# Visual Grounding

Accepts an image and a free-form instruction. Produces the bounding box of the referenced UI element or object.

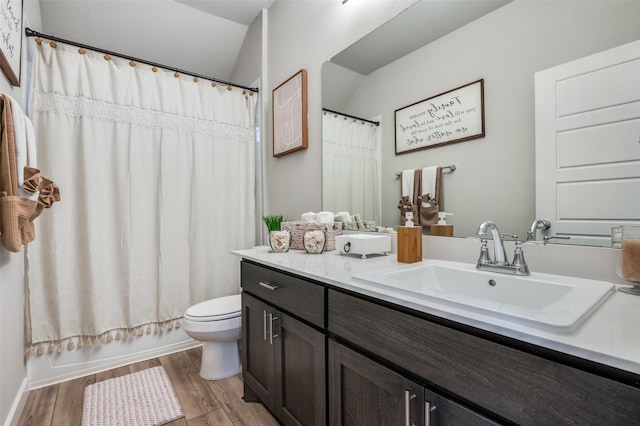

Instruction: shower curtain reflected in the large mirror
[322,113,382,225]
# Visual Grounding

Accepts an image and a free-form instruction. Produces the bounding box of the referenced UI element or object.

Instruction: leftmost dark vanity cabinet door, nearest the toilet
[242,293,275,409]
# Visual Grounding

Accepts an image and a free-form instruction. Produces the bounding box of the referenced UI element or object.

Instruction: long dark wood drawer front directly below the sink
[328,290,640,425]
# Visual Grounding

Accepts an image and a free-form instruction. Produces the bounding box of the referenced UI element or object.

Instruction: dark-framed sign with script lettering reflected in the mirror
[395,79,485,155]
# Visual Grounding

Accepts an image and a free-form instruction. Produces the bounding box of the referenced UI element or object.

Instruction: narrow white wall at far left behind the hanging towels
[0,0,40,424]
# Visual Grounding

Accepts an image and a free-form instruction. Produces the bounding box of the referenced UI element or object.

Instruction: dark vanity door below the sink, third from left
[329,340,425,426]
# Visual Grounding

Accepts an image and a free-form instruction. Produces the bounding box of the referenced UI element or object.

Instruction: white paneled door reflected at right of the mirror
[535,41,640,245]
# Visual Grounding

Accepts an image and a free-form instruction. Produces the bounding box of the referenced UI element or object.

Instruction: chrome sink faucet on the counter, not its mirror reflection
[476,221,531,275]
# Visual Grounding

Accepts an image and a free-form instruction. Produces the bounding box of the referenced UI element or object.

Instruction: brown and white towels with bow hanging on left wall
[0,94,60,252]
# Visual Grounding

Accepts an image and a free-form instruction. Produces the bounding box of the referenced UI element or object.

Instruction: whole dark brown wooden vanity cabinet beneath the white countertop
[241,260,640,426]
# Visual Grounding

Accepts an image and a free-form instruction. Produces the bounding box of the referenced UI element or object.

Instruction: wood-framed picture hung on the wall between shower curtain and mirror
[272,69,307,157]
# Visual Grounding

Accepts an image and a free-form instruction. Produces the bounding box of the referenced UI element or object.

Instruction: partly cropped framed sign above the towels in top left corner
[0,0,22,86]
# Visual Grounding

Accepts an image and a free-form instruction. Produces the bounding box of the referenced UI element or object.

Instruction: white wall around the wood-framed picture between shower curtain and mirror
[262,0,414,219]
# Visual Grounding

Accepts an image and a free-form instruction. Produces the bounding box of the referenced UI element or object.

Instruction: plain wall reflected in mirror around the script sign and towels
[344,1,640,238]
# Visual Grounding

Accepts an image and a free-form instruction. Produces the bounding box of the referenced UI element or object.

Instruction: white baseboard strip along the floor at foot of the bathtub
[29,339,202,390]
